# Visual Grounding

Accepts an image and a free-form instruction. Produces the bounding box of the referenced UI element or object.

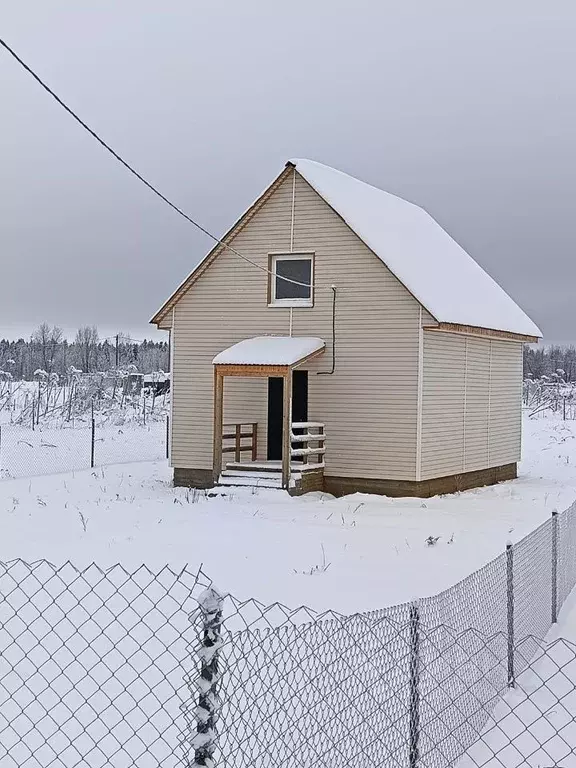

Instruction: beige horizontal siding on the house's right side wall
[421,331,522,479]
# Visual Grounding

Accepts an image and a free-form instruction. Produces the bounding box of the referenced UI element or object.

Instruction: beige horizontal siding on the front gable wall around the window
[172,175,424,480]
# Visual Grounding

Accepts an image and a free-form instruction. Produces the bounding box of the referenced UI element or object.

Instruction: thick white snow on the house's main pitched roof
[290,160,542,336]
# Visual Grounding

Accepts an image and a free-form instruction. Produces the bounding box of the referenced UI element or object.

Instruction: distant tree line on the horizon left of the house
[0,323,170,379]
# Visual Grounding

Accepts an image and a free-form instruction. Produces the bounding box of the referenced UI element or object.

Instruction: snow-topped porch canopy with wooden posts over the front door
[213,336,326,488]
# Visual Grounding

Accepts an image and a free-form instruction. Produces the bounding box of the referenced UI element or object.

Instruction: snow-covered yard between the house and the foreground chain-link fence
[0,408,576,613]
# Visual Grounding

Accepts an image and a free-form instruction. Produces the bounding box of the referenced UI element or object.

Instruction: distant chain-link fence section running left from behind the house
[0,417,169,478]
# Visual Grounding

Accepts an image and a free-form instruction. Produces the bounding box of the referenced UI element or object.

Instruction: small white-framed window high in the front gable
[270,253,314,307]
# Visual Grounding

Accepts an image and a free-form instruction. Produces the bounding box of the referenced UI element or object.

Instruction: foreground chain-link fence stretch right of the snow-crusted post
[211,506,576,768]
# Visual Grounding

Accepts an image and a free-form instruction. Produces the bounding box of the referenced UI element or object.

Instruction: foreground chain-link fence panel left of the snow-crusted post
[0,561,198,768]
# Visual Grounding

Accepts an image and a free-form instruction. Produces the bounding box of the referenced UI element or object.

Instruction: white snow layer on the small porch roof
[213,336,326,365]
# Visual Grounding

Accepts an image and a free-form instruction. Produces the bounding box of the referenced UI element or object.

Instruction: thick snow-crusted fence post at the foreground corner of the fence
[192,587,224,768]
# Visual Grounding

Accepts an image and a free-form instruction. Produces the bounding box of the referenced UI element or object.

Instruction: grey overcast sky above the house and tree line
[0,0,576,342]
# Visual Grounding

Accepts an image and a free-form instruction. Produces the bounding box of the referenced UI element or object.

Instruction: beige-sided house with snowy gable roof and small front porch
[151,160,541,496]
